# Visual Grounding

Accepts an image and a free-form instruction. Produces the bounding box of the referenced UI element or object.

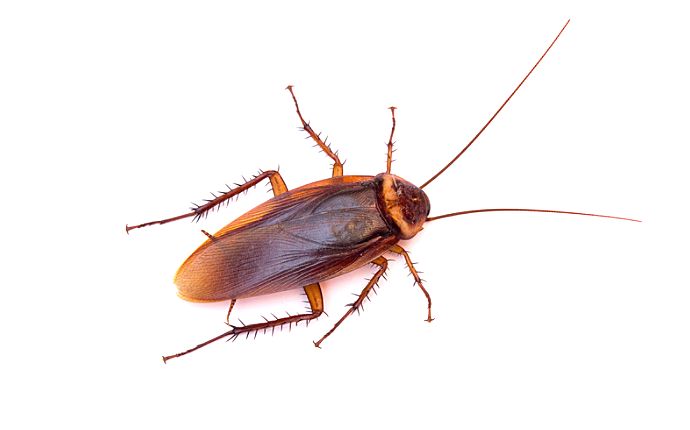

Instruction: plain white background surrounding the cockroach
[0,1,690,429]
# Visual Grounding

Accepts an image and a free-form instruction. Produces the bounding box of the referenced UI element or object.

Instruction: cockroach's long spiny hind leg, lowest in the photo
[163,284,323,362]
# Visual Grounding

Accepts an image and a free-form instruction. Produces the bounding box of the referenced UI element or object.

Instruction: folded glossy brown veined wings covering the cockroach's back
[175,177,397,301]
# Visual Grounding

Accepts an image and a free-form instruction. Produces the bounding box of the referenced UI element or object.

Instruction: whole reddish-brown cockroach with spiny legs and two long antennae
[126,20,639,362]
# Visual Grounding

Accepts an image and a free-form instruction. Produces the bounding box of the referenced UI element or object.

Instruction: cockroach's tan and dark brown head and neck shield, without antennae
[375,173,431,239]
